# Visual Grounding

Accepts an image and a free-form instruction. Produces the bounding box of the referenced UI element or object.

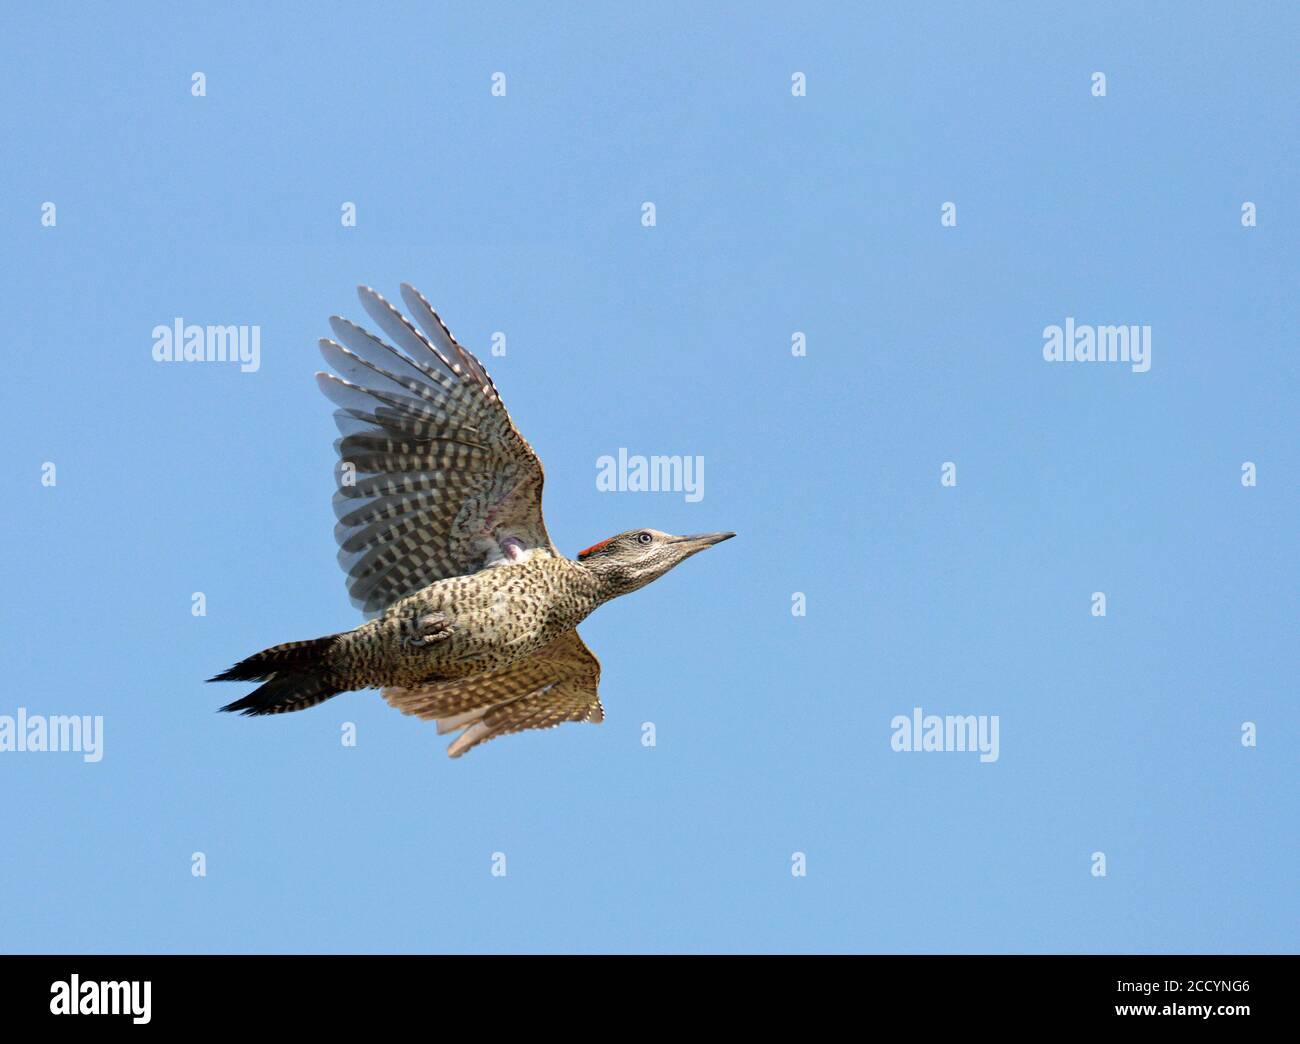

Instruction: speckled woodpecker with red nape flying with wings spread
[209,283,736,758]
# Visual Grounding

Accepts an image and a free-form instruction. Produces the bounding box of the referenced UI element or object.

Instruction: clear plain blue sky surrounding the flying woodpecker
[0,3,1300,952]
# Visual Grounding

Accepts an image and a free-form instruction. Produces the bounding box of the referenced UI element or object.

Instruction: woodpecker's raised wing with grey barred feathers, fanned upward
[316,283,558,615]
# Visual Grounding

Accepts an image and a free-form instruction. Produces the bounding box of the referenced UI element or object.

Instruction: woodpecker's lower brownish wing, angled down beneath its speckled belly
[384,631,605,758]
